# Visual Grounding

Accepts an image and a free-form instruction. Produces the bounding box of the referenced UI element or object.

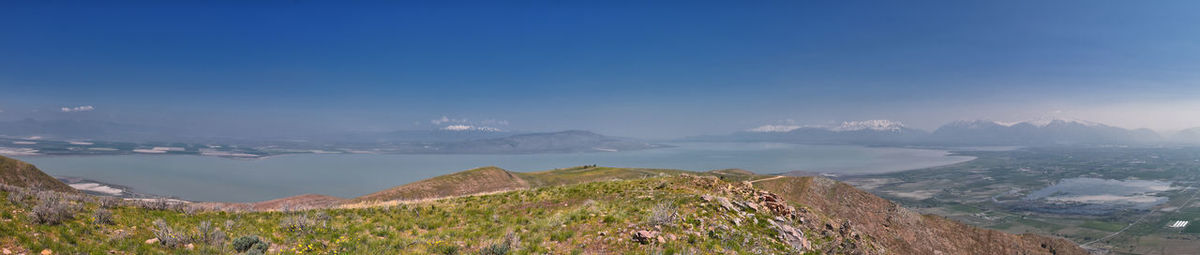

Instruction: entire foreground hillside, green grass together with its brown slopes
[0,157,1085,254]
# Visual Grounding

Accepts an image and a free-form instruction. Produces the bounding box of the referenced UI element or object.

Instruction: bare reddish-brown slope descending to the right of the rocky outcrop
[754,177,1087,254]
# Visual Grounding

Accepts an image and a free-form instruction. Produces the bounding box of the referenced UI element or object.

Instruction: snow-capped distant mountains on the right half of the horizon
[683,119,1200,146]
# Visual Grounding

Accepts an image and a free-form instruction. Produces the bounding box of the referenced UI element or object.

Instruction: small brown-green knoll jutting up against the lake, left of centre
[349,166,529,203]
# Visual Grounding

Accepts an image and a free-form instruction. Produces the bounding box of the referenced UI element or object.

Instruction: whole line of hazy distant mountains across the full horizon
[0,119,1200,154]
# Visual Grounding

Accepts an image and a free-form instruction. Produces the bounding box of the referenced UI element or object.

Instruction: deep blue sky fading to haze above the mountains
[0,0,1200,137]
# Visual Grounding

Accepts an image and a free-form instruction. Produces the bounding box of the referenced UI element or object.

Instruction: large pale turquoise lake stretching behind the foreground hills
[19,143,973,202]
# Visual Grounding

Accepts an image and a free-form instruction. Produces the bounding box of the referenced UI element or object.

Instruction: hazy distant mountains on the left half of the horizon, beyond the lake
[0,119,667,153]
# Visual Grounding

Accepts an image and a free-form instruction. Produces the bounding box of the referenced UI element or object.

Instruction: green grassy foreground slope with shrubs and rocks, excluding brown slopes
[0,173,824,254]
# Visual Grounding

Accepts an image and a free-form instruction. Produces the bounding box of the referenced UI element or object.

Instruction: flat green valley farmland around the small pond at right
[840,147,1200,254]
